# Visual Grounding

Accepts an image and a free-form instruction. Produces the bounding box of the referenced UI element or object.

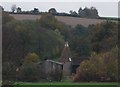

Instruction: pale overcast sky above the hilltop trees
[0,0,118,17]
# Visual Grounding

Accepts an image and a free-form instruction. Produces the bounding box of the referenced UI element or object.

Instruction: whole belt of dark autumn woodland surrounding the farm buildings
[2,9,118,82]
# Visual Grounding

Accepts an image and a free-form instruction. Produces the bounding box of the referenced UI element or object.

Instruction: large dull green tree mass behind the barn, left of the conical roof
[14,19,64,60]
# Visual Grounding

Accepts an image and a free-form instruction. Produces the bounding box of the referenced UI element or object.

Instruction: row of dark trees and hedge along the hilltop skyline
[3,5,99,18]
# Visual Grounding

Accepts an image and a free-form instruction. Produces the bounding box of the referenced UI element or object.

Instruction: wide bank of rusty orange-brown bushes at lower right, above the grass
[74,47,118,82]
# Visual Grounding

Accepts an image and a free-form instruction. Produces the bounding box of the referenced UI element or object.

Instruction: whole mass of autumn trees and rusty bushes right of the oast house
[74,21,119,81]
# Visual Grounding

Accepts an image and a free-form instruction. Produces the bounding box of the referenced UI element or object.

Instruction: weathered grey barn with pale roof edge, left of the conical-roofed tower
[43,60,63,81]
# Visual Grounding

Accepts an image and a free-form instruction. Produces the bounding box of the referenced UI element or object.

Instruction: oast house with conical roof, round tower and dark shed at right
[60,42,83,76]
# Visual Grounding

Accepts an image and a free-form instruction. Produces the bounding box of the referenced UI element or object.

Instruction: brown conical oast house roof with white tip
[61,42,72,62]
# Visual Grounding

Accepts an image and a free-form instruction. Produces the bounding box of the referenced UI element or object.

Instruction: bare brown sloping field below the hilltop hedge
[10,14,105,27]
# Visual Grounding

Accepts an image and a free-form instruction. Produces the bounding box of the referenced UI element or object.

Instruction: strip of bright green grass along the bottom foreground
[15,82,120,87]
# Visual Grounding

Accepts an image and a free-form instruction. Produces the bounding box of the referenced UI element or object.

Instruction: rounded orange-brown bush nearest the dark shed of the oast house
[74,60,97,81]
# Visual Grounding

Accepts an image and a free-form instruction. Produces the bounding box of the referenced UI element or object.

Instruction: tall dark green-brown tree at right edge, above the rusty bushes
[91,21,118,53]
